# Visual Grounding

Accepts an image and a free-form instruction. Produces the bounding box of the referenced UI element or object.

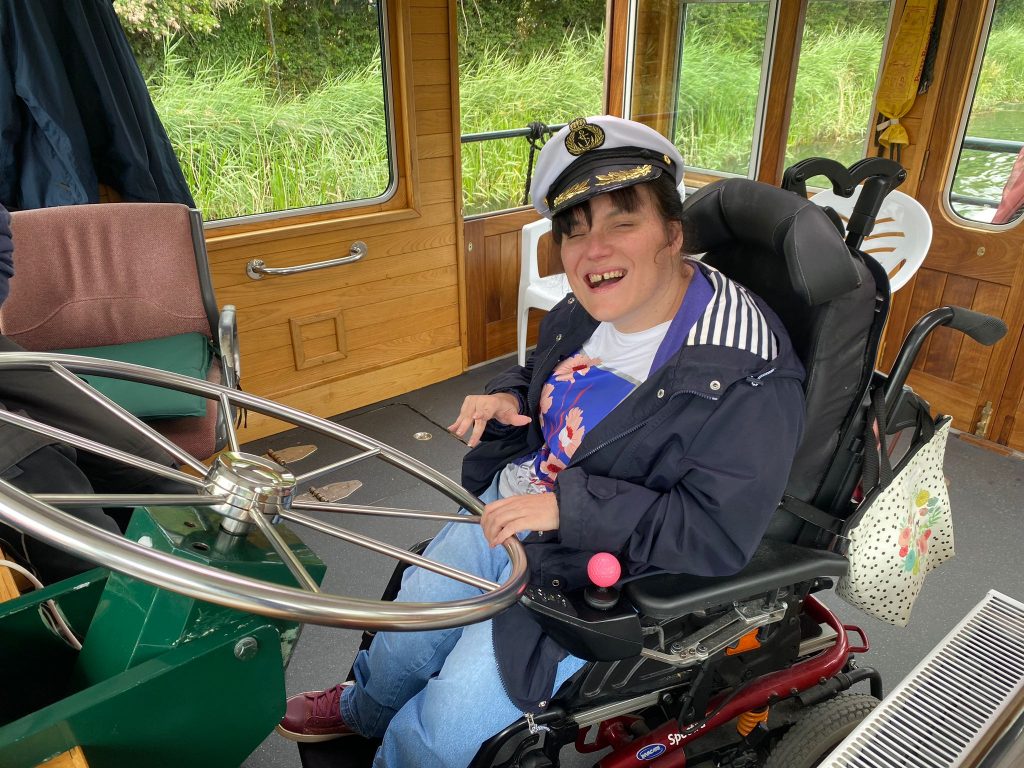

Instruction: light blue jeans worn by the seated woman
[341,481,585,768]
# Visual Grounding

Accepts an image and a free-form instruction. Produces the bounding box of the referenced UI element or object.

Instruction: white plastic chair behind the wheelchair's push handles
[811,186,932,293]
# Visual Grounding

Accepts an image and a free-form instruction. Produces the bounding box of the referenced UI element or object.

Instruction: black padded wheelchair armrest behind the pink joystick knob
[623,539,848,618]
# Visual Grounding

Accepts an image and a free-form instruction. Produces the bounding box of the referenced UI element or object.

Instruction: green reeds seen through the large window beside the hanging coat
[150,44,388,220]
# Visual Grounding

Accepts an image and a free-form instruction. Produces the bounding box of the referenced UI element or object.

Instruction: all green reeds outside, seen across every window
[150,27,1024,219]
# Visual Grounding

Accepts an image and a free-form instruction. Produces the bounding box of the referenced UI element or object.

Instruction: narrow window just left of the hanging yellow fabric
[785,0,892,166]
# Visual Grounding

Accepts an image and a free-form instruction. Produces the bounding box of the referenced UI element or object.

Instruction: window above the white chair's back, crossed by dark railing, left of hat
[457,0,606,216]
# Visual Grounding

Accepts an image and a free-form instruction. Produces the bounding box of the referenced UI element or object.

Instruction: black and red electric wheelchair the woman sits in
[300,159,1005,768]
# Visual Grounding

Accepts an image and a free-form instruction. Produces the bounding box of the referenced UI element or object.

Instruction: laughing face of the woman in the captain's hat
[561,186,687,333]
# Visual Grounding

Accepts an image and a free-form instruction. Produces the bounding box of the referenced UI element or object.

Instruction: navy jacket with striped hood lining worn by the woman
[462,264,804,713]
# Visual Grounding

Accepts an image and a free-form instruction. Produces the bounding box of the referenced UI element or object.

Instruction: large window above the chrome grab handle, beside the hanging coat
[114,0,397,223]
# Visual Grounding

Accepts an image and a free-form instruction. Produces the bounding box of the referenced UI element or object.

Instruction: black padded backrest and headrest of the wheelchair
[684,178,889,541]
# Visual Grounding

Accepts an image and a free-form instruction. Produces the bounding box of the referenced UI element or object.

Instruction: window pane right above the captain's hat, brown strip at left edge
[628,0,776,177]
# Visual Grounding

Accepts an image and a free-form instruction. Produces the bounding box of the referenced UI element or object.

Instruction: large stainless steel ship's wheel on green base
[0,352,526,630]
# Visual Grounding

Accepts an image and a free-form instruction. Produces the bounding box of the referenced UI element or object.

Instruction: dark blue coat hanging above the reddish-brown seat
[0,0,195,210]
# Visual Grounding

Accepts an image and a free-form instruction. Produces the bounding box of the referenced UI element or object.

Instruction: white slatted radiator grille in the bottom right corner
[820,591,1024,768]
